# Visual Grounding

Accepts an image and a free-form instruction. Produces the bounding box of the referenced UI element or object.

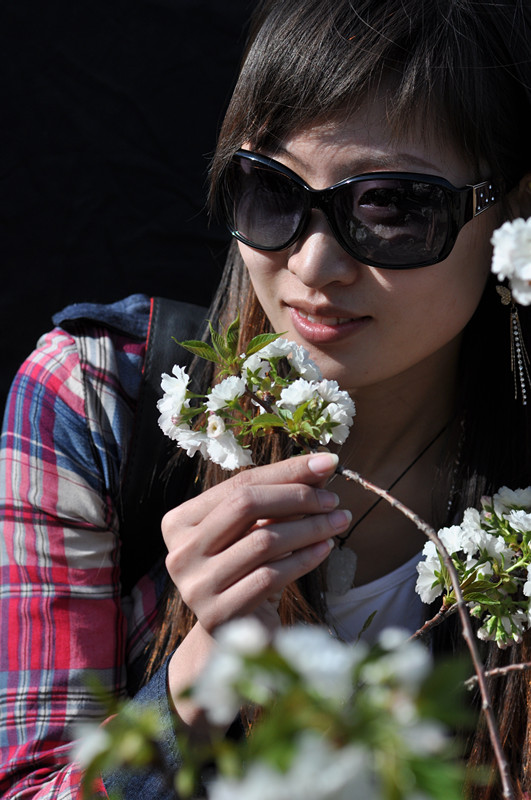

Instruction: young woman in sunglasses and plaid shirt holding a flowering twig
[1,0,531,798]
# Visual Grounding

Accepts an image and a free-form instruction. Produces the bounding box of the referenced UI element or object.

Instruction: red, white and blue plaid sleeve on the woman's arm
[0,322,147,800]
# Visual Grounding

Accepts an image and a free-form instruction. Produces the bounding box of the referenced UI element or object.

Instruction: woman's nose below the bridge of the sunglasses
[288,210,361,289]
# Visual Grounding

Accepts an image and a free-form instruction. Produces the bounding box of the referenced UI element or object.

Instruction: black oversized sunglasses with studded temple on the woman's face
[219,150,500,269]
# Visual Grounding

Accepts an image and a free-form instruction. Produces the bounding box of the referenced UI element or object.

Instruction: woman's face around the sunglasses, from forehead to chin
[239,103,499,391]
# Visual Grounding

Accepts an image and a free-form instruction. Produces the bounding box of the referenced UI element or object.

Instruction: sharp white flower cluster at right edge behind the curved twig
[416,486,531,648]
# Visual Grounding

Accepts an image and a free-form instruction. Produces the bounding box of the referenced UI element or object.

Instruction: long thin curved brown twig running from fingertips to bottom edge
[336,466,515,800]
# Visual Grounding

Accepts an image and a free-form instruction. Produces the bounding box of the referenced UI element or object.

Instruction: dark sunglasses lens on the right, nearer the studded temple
[334,178,450,267]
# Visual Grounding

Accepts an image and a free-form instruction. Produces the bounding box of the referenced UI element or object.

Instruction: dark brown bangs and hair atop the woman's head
[212,0,530,203]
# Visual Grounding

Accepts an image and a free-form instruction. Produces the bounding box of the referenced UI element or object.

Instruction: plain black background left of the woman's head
[0,0,254,409]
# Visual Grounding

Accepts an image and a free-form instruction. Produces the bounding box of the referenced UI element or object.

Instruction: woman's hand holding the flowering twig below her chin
[162,453,351,633]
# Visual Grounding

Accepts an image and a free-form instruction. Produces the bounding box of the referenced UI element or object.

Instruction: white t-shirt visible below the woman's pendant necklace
[326,553,429,644]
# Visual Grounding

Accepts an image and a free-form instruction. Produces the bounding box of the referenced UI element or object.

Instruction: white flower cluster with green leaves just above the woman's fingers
[157,321,355,470]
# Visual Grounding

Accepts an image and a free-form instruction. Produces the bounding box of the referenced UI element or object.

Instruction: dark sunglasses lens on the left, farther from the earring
[225,156,304,249]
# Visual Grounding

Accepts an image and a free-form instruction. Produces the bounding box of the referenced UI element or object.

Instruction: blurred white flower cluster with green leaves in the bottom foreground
[192,618,462,800]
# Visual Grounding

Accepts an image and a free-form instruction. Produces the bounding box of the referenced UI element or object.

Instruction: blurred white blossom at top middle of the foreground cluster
[275,625,366,701]
